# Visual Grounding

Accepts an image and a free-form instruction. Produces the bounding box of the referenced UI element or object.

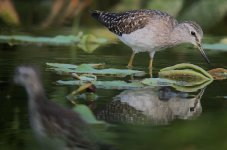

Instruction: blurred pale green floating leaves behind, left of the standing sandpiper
[0,33,108,53]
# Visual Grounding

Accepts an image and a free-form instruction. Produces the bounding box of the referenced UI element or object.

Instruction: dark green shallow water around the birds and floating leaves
[0,34,227,150]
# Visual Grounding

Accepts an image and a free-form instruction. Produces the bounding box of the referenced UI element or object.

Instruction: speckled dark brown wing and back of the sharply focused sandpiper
[91,10,169,36]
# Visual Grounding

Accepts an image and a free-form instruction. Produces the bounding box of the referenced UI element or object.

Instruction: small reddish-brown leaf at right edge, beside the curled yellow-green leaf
[208,68,227,80]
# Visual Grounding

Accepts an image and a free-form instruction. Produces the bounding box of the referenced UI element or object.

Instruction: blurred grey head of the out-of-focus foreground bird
[14,66,40,86]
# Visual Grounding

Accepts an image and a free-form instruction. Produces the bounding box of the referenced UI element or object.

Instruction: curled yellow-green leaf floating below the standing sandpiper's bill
[159,63,213,92]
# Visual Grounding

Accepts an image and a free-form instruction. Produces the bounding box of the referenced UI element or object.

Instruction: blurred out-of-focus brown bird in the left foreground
[14,66,99,150]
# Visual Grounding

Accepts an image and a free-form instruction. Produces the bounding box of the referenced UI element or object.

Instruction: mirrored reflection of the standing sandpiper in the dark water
[97,87,204,125]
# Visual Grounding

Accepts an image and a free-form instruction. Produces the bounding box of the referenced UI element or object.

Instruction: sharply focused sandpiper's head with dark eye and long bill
[180,21,210,63]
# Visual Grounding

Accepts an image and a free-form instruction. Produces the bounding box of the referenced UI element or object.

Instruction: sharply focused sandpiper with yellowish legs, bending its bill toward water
[91,9,210,76]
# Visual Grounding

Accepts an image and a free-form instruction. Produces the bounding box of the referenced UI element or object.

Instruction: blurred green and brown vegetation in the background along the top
[0,0,227,35]
